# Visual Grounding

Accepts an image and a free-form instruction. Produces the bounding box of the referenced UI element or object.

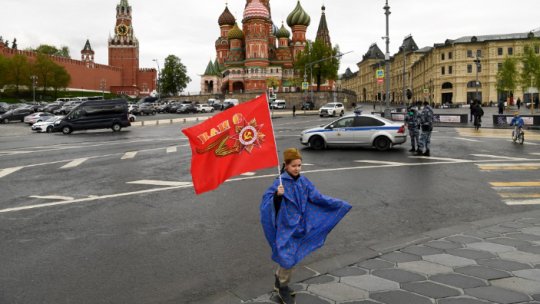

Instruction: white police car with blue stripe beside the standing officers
[300,114,407,151]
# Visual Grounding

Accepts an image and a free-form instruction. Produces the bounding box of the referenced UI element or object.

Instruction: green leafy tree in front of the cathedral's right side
[294,41,340,92]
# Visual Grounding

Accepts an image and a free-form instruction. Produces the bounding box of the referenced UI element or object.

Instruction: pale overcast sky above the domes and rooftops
[0,0,540,92]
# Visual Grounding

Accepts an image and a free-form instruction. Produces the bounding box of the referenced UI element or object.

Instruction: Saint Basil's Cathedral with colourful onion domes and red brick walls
[201,0,333,94]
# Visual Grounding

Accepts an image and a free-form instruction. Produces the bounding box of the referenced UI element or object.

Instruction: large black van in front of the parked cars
[53,99,131,134]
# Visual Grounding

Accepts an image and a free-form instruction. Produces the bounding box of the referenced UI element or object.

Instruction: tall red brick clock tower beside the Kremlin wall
[109,0,139,87]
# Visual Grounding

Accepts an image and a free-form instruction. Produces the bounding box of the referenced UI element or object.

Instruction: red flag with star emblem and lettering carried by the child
[182,95,279,194]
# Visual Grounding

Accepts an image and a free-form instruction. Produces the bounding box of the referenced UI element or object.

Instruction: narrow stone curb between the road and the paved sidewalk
[199,210,540,304]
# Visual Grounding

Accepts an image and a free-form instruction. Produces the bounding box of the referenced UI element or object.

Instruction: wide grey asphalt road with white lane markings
[0,115,540,304]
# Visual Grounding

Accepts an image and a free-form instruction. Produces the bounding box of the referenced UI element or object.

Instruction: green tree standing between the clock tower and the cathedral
[159,55,191,96]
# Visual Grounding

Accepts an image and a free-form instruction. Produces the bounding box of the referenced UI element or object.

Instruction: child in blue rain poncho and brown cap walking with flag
[261,148,351,304]
